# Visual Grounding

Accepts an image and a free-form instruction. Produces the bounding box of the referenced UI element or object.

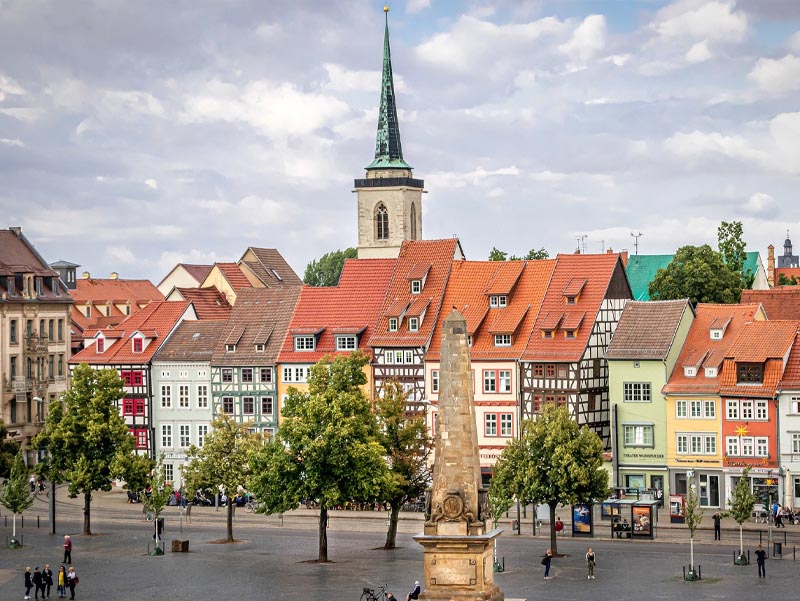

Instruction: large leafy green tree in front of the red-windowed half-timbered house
[33,364,134,534]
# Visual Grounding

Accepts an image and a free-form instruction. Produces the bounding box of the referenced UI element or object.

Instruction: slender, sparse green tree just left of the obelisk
[375,380,432,549]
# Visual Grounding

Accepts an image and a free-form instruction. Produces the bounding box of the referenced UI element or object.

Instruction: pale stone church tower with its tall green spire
[355,6,425,259]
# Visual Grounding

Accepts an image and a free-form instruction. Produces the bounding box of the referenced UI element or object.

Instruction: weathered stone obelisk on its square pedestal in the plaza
[414,309,503,601]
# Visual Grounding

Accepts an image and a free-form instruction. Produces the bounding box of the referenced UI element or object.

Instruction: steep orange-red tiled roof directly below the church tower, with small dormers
[368,238,460,348]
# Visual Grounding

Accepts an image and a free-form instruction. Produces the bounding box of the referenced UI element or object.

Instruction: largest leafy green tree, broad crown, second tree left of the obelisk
[250,352,388,562]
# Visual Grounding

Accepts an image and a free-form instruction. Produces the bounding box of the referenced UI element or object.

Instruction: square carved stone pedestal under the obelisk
[414,530,504,601]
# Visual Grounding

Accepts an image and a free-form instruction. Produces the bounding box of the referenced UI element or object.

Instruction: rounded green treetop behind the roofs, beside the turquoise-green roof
[649,244,742,305]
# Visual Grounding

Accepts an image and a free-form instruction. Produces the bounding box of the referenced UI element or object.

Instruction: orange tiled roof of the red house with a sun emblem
[720,321,800,397]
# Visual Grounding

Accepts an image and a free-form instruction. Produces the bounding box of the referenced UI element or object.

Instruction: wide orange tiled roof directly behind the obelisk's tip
[425,259,556,361]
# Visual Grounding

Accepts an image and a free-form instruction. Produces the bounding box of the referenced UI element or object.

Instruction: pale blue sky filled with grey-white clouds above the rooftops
[0,0,800,283]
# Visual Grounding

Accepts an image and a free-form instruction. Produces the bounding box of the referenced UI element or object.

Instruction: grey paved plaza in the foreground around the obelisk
[0,491,800,601]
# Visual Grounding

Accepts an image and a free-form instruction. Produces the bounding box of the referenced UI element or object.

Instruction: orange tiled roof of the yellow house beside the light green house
[663,303,764,394]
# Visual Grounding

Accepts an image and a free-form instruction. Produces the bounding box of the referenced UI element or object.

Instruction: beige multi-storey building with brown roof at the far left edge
[0,227,73,465]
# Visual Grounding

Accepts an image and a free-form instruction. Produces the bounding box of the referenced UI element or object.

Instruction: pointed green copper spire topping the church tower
[367,6,411,169]
